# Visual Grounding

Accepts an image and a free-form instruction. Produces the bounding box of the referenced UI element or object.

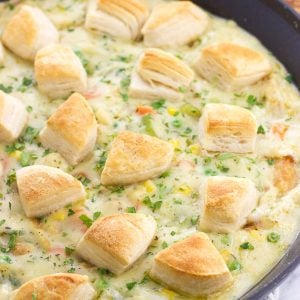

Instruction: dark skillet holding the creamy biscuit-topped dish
[0,0,300,300]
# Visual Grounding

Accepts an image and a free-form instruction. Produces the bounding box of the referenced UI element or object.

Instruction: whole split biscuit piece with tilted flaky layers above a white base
[129,48,194,100]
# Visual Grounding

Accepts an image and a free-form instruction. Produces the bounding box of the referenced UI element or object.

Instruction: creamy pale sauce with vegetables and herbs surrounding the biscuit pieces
[0,0,300,299]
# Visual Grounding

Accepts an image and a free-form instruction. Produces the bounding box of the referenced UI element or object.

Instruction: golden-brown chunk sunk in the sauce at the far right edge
[274,156,298,194]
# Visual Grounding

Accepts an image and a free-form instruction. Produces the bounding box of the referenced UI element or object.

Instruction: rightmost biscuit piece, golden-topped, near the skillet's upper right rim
[195,43,271,90]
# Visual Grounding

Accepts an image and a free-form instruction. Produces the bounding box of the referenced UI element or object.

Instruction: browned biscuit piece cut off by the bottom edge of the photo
[9,273,96,300]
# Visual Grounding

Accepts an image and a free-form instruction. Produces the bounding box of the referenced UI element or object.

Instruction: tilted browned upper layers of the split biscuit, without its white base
[137,48,194,90]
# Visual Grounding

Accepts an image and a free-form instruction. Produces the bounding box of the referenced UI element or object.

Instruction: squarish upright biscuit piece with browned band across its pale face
[199,103,257,153]
